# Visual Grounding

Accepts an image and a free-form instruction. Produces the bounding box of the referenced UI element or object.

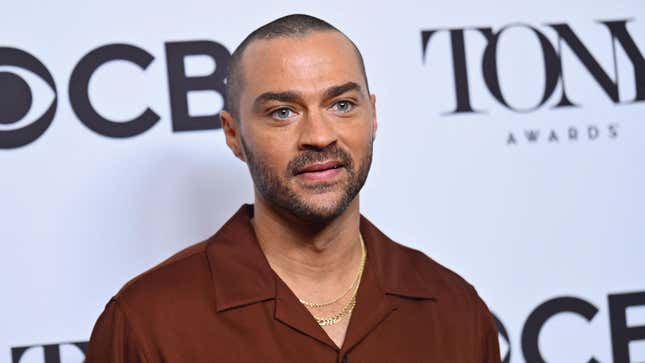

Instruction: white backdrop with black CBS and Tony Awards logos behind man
[0,0,645,363]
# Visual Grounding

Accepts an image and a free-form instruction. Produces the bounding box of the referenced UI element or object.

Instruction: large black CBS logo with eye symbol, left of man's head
[0,41,230,149]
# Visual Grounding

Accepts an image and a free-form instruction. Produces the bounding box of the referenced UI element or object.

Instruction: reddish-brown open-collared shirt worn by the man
[86,205,500,363]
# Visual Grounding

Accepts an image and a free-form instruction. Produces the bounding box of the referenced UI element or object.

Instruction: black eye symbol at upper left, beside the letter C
[0,47,58,149]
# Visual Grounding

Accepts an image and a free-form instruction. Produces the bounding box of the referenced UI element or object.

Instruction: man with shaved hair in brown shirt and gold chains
[87,15,500,363]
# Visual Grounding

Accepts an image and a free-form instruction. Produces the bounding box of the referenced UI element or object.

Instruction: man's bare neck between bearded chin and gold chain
[253,193,361,300]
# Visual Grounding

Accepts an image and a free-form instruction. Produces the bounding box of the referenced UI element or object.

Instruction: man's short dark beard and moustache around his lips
[241,138,374,224]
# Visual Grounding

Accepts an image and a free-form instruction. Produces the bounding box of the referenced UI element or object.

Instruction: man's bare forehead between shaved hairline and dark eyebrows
[240,31,366,99]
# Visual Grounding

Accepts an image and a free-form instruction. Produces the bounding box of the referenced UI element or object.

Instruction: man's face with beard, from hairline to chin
[225,31,376,222]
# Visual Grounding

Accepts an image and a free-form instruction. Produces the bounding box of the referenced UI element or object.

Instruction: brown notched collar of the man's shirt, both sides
[206,204,438,312]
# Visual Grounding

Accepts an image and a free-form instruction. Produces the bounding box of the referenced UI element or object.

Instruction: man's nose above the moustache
[298,111,337,150]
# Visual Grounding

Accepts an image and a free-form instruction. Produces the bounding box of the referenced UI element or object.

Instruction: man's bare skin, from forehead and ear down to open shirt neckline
[221,31,377,347]
